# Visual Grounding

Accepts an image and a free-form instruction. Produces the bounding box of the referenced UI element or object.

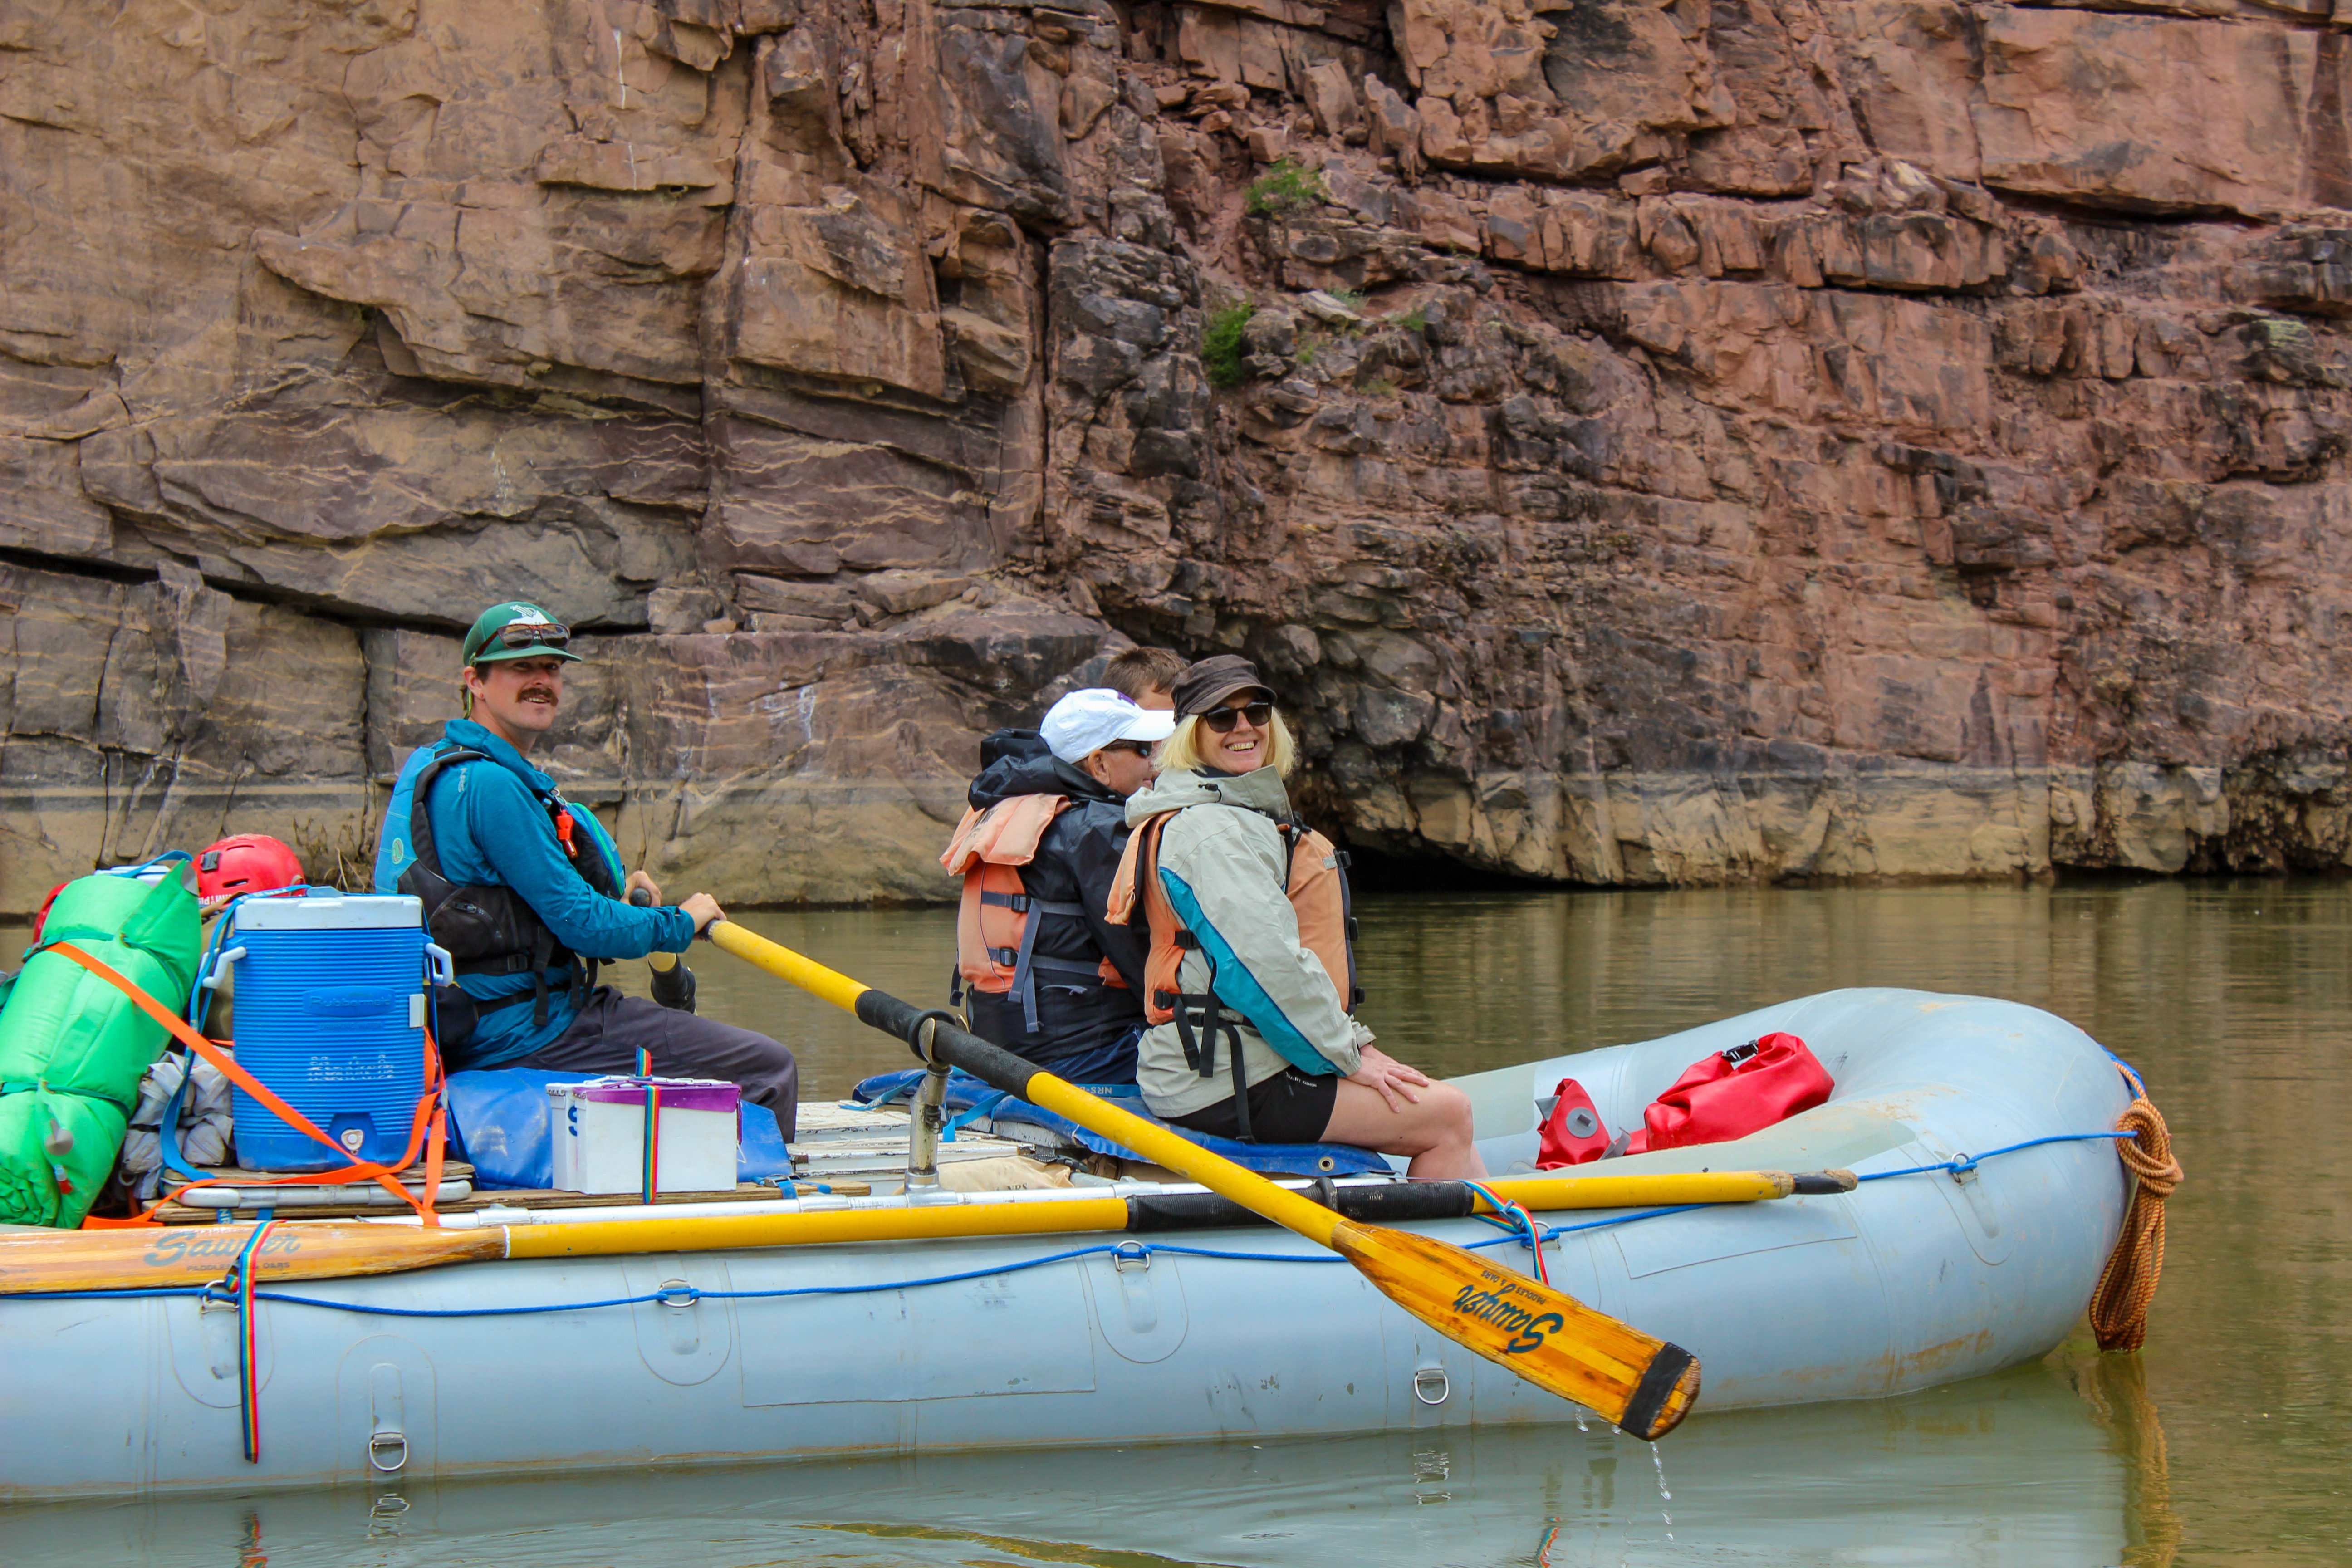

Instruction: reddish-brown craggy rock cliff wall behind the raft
[0,0,2352,907]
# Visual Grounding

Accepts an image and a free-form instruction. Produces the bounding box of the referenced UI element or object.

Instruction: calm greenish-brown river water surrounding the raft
[0,882,2352,1568]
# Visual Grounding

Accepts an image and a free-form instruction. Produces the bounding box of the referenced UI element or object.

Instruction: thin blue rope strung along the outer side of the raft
[14,1133,2131,1319]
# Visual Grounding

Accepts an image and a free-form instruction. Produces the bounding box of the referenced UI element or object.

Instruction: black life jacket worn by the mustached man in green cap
[397,748,621,1051]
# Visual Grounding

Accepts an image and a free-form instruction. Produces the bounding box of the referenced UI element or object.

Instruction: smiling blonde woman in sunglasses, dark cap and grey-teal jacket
[1110,653,1486,1180]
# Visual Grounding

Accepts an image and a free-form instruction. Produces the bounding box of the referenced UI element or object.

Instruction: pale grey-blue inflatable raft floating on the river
[0,990,2131,1500]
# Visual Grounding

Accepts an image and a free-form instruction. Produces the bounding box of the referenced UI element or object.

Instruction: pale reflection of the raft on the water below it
[0,1366,2129,1568]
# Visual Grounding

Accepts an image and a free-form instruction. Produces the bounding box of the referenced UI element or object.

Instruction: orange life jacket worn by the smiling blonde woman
[1105,806,1364,1142]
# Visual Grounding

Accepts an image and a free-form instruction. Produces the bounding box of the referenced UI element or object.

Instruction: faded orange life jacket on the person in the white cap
[938,794,1127,1034]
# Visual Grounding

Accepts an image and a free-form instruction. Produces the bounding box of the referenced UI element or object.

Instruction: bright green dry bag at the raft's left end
[0,856,202,1230]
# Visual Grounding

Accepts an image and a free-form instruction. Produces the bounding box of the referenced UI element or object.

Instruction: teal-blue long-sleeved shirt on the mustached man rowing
[426,720,694,1067]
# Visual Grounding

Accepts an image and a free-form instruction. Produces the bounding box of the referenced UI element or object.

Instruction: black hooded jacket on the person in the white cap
[969,729,1148,1077]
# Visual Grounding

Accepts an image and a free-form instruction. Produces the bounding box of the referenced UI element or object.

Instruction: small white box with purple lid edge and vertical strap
[548,1077,743,1192]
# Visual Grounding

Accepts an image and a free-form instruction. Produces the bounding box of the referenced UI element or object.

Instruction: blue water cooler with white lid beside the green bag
[207,889,451,1171]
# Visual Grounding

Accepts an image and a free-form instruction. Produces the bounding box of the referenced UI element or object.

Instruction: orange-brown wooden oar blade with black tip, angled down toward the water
[1331,1220,1698,1441]
